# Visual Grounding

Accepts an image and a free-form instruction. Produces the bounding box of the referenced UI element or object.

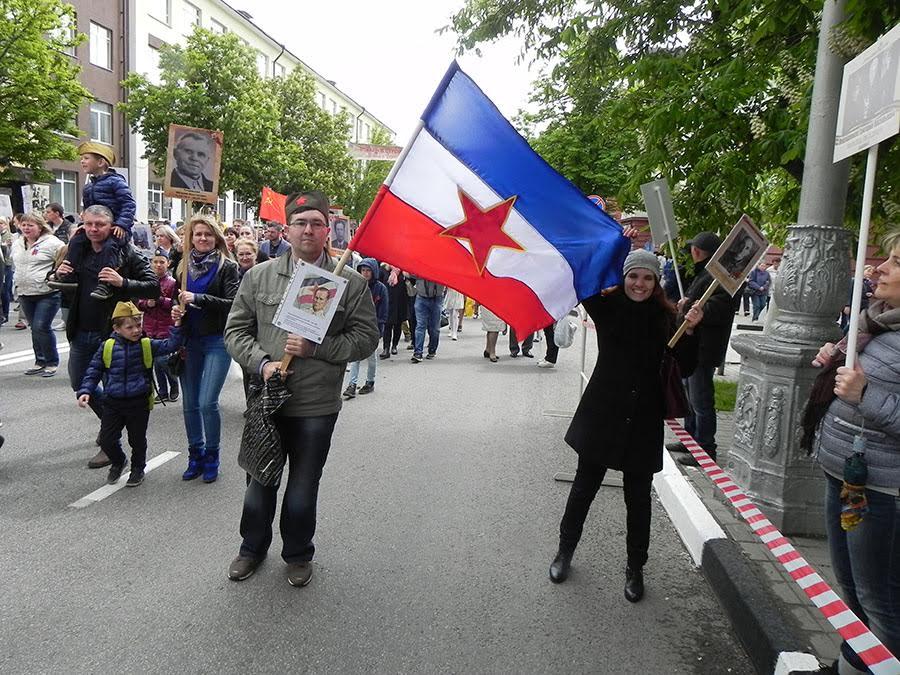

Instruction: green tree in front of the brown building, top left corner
[0,0,90,180]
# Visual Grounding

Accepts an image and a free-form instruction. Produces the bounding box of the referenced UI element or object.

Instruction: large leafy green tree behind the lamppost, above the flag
[449,0,900,239]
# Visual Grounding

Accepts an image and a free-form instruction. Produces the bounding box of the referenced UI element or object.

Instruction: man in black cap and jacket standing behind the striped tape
[666,232,743,466]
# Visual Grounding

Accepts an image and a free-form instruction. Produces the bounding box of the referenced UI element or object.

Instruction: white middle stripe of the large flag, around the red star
[390,129,578,319]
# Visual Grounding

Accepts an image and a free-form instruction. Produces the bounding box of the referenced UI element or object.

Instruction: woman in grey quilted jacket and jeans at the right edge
[813,230,900,673]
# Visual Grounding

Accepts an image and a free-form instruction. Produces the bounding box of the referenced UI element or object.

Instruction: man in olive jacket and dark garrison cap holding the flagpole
[225,191,379,587]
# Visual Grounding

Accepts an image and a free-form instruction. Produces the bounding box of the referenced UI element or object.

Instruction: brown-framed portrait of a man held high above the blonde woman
[163,124,223,204]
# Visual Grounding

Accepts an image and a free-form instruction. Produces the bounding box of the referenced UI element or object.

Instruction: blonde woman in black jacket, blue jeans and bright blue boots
[172,215,239,483]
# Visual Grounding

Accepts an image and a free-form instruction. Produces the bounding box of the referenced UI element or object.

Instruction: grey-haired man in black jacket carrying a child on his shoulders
[56,204,160,469]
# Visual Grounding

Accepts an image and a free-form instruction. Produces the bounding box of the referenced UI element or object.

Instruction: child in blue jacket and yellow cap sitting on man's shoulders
[50,141,137,301]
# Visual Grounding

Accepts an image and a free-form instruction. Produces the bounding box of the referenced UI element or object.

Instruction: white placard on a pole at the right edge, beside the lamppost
[834,24,900,162]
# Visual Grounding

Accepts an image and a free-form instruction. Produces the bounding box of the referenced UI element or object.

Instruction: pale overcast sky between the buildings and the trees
[236,0,537,145]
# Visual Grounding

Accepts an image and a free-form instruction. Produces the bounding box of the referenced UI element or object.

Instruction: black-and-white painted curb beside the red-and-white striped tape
[653,450,819,675]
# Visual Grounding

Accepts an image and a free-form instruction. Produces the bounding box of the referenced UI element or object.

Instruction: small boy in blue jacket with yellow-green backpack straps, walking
[77,302,182,487]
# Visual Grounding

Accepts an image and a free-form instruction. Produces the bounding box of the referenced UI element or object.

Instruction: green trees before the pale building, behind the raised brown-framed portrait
[120,28,353,209]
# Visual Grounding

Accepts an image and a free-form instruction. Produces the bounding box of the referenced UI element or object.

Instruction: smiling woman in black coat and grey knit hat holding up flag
[550,246,703,602]
